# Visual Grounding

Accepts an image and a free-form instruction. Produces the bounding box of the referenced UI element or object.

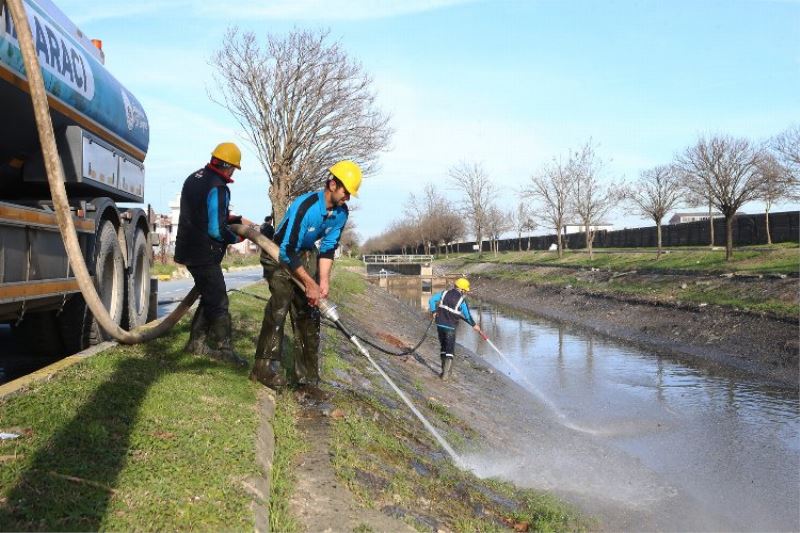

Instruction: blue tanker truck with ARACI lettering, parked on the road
[0,0,153,356]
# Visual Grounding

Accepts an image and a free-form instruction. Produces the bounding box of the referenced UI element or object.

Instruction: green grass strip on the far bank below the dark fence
[437,244,800,319]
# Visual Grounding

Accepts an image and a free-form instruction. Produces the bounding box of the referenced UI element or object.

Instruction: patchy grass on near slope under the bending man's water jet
[323,272,589,531]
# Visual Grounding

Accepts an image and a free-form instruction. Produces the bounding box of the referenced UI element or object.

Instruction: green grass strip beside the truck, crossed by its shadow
[0,297,259,530]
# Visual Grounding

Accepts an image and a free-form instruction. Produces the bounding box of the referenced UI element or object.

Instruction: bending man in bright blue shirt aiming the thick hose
[250,160,361,392]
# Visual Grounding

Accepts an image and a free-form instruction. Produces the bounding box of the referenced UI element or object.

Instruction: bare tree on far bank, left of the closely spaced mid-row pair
[524,158,572,257]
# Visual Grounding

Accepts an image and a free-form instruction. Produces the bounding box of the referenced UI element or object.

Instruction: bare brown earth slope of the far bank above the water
[446,264,800,387]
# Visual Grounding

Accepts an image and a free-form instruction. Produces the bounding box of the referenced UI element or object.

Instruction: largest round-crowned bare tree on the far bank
[677,135,764,260]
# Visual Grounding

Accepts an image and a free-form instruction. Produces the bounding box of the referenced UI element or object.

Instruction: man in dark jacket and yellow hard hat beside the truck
[175,143,247,366]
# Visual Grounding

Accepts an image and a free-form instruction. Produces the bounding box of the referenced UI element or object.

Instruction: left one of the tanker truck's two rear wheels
[91,220,125,344]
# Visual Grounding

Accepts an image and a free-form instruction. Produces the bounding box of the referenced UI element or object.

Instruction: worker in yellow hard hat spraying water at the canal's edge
[428,278,483,380]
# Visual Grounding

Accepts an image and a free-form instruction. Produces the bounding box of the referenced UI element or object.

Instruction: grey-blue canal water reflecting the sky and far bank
[382,280,800,530]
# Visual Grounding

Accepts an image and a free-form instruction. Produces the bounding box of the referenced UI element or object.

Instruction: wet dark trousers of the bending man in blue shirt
[256,250,319,385]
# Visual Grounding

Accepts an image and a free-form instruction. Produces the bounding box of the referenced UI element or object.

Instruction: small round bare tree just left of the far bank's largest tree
[625,165,683,261]
